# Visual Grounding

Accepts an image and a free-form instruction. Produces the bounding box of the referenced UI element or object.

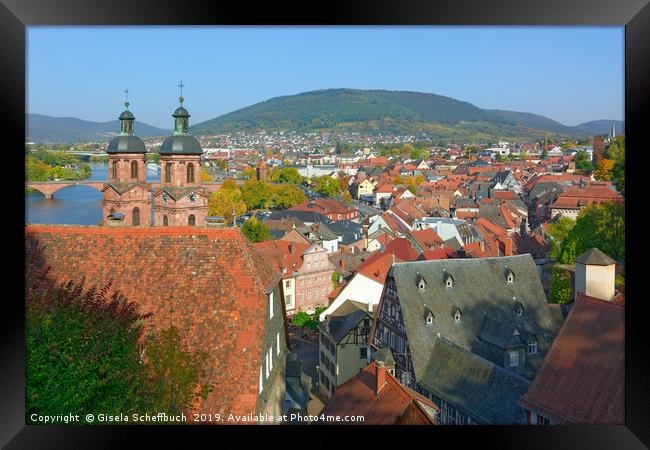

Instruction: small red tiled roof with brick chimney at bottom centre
[321,362,439,425]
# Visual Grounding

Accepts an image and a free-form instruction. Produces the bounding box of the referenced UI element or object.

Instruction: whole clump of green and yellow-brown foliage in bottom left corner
[25,282,210,423]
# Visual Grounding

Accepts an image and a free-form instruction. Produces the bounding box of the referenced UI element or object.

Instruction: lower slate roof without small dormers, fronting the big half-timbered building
[418,336,530,425]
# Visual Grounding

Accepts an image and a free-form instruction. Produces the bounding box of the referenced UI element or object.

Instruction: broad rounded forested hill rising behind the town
[191,89,612,140]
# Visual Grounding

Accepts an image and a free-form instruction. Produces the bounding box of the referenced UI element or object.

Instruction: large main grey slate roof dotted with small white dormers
[389,255,563,380]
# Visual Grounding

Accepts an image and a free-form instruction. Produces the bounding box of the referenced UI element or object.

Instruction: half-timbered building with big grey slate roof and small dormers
[371,255,563,424]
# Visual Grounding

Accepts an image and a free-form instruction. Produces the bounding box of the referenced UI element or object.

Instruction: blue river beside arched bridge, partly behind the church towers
[25,163,160,225]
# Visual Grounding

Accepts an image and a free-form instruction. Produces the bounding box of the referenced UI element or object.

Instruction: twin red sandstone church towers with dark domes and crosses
[103,82,209,226]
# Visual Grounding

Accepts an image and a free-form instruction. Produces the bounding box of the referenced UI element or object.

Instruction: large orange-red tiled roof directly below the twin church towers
[25,225,280,420]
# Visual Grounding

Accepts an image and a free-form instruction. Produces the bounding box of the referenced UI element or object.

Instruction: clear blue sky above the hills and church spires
[27,26,624,132]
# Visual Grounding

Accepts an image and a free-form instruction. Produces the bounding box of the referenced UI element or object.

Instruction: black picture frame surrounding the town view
[0,0,650,449]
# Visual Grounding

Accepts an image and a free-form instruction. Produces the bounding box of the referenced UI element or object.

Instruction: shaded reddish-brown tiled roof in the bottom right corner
[520,294,625,424]
